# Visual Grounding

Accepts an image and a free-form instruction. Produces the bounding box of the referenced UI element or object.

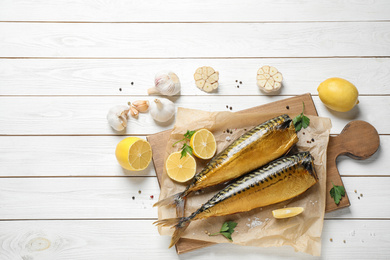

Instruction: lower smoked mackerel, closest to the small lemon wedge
[155,152,318,247]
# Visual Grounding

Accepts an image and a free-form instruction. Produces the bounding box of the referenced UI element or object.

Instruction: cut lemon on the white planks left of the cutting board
[115,137,152,171]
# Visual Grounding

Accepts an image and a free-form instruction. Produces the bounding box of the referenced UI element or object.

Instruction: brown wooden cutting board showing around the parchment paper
[147,94,379,254]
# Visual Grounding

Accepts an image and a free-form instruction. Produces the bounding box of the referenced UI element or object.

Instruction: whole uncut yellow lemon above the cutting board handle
[317,78,359,112]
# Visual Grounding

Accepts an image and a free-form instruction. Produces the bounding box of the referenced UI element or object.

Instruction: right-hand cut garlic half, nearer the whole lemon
[256,66,283,93]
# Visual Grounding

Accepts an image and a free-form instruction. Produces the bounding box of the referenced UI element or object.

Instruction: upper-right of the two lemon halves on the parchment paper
[190,129,217,159]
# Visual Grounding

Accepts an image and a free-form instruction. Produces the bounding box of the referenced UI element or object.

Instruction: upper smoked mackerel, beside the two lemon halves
[154,115,298,216]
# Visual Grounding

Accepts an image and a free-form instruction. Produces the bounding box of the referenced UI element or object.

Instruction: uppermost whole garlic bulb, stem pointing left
[148,71,181,96]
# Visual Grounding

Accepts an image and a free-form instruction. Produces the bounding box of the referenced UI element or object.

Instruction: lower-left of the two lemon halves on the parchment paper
[165,151,196,182]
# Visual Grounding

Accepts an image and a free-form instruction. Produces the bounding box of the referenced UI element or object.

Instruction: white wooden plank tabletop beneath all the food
[0,0,390,260]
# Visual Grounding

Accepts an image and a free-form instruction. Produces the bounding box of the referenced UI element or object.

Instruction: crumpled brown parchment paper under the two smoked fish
[158,108,331,256]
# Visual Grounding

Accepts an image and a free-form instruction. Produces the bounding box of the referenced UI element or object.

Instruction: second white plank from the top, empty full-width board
[0,22,390,58]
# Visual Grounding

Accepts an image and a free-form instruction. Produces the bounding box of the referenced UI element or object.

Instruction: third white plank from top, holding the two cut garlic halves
[0,58,390,96]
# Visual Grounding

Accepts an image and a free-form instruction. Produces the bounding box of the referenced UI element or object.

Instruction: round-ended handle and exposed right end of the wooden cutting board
[326,120,379,211]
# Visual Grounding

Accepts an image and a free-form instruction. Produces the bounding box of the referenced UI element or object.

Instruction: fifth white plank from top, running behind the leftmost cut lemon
[0,135,390,177]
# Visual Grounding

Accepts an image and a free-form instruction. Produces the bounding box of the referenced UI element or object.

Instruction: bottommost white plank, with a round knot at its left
[0,220,390,260]
